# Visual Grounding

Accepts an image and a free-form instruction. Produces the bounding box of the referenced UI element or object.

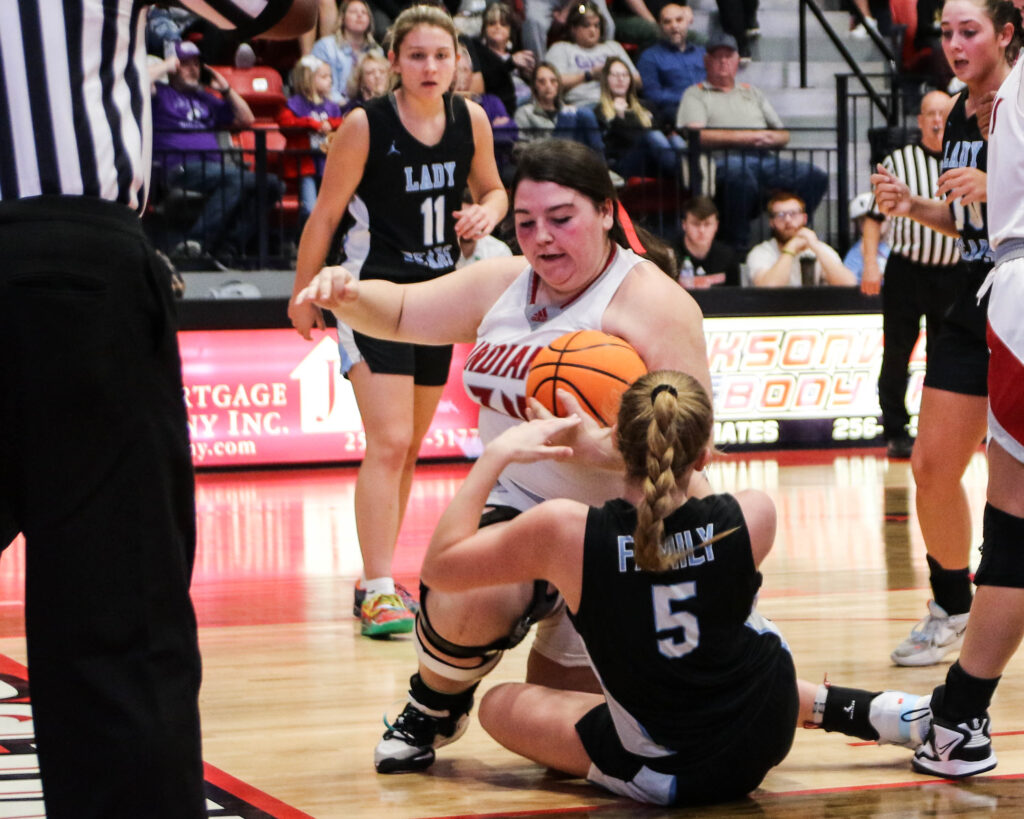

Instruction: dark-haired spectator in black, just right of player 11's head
[476,2,537,114]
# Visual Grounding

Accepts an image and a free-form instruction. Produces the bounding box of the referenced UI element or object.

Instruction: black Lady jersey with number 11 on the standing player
[345,94,473,282]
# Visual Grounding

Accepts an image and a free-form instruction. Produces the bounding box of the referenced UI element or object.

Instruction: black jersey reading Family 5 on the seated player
[569,494,792,762]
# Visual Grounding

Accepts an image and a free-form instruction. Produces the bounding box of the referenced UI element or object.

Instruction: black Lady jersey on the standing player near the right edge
[941,90,992,266]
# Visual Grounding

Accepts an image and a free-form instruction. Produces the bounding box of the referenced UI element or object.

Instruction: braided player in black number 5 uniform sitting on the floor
[422,371,930,805]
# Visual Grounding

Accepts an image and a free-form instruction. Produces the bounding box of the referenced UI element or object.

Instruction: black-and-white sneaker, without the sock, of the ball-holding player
[374,695,473,774]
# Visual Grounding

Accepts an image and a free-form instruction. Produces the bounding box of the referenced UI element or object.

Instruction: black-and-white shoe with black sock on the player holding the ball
[374,674,476,774]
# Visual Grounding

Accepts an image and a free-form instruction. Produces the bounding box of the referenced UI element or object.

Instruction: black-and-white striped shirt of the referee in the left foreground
[0,0,291,210]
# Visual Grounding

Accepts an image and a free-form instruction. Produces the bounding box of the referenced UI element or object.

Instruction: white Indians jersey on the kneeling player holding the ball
[463,247,643,510]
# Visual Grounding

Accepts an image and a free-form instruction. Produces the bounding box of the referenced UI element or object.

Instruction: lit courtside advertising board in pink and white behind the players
[179,314,925,467]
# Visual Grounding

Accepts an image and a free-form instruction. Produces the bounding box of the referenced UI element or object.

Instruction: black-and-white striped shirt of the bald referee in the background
[871,144,959,267]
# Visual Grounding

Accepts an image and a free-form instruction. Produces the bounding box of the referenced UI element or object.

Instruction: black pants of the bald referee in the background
[879,253,966,440]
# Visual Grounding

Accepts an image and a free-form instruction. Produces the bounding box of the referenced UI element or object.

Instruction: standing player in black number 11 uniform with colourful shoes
[288,5,508,637]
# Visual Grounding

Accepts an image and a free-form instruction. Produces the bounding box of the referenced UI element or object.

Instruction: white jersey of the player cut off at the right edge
[988,59,1024,248]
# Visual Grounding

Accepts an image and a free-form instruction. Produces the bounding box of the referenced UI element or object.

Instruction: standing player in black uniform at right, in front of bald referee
[871,0,1017,665]
